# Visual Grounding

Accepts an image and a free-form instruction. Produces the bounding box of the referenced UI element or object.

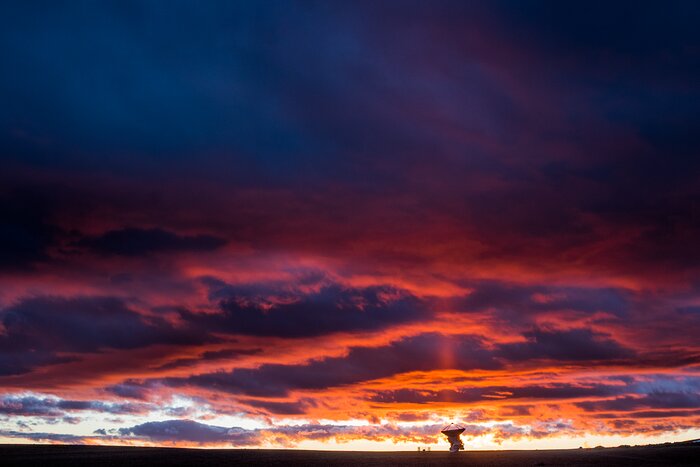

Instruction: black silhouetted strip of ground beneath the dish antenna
[0,443,700,467]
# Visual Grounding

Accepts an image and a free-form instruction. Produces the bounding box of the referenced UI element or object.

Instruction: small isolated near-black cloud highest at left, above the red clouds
[75,228,226,257]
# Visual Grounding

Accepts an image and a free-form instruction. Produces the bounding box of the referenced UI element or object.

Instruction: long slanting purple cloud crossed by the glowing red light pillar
[165,333,500,397]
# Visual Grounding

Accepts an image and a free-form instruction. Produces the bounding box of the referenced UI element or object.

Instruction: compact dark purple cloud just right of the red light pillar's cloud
[497,329,635,362]
